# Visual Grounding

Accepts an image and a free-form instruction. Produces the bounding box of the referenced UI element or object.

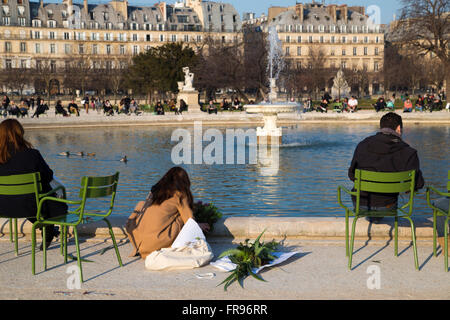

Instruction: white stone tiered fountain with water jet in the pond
[244,26,300,144]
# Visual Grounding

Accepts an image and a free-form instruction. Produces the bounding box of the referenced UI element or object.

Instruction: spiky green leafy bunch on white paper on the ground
[219,230,279,291]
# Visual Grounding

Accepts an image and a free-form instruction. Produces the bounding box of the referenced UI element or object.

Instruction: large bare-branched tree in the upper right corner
[394,0,450,97]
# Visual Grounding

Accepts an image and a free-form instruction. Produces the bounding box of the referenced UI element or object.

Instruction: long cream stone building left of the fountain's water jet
[0,0,242,92]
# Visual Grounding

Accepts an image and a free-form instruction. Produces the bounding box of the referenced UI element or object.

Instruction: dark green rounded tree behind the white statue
[126,43,197,94]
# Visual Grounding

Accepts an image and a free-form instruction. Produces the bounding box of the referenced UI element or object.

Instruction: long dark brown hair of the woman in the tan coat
[151,167,194,209]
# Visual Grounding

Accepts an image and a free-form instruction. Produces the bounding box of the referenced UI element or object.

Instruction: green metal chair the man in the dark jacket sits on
[337,169,419,270]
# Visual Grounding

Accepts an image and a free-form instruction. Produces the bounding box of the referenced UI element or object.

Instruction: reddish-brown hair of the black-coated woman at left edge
[0,119,32,164]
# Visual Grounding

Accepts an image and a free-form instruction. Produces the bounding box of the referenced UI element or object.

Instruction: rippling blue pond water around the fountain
[26,124,450,217]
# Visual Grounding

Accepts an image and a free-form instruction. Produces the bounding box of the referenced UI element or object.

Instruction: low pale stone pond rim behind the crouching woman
[0,216,433,240]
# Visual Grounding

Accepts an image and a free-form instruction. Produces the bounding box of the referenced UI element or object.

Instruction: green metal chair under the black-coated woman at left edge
[0,172,66,256]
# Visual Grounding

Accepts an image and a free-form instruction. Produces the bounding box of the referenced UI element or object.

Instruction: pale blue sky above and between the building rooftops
[40,0,402,24]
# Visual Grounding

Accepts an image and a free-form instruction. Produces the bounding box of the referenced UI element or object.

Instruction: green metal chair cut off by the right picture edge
[427,171,450,272]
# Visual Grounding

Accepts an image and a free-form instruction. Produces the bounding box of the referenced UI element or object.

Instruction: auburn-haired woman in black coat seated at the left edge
[0,119,68,250]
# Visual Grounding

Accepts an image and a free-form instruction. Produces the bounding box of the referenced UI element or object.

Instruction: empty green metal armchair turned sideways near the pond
[31,172,122,282]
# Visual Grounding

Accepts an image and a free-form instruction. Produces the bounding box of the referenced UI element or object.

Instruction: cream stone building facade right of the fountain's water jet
[243,3,385,95]
